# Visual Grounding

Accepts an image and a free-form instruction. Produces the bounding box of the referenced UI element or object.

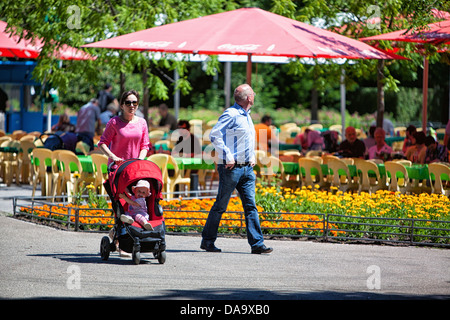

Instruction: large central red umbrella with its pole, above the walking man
[83,8,397,84]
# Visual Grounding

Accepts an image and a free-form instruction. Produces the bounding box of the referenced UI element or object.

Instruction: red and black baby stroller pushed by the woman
[100,159,166,264]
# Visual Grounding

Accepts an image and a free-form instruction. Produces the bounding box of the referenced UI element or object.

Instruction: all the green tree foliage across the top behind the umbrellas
[0,0,450,121]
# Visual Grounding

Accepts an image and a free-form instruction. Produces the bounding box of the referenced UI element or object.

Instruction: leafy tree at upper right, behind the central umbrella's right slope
[274,0,450,126]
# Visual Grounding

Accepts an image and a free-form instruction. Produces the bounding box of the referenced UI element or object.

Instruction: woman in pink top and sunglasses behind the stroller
[98,90,150,165]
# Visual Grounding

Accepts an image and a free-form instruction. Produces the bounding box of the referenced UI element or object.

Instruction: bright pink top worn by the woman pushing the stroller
[98,116,150,164]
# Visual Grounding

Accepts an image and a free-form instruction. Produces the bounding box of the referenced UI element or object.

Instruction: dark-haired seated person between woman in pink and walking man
[172,120,202,158]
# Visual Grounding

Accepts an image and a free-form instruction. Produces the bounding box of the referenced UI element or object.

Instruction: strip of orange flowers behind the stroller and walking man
[21,197,336,234]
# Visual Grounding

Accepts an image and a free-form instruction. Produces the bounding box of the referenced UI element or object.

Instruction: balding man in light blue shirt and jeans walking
[200,84,273,254]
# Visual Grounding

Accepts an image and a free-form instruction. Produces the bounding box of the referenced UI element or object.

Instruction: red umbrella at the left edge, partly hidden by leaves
[0,21,94,60]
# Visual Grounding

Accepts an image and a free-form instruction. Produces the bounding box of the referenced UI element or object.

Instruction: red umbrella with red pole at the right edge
[361,19,450,132]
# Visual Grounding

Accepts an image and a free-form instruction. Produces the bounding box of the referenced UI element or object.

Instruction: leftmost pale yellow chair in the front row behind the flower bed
[31,148,53,198]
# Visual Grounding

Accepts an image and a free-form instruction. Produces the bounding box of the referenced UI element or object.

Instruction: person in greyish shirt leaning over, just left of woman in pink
[75,99,101,151]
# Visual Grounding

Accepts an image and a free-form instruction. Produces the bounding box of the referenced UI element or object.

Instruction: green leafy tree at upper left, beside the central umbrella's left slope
[0,0,239,120]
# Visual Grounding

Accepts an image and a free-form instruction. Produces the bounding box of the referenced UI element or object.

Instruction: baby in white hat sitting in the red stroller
[119,180,153,231]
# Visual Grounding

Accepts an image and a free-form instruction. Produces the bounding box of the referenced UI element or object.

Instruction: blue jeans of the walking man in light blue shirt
[202,164,264,248]
